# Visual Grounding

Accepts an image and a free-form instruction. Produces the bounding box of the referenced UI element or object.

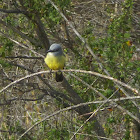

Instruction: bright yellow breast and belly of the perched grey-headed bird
[45,53,66,70]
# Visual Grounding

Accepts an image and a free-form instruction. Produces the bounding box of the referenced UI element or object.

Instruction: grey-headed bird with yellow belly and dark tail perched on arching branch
[44,43,66,82]
